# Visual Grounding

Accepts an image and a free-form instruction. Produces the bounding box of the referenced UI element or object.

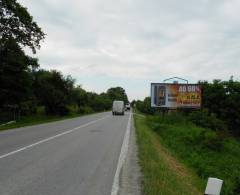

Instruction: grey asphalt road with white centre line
[0,112,130,195]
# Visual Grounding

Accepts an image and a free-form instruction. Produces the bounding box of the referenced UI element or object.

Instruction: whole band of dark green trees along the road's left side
[0,0,128,123]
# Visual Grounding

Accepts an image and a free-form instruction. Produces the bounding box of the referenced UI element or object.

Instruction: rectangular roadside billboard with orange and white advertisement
[151,83,202,109]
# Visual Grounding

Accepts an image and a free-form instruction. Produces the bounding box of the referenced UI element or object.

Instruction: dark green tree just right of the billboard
[200,78,240,135]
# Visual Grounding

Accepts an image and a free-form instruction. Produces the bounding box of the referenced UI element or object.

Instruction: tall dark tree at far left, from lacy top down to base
[0,0,45,120]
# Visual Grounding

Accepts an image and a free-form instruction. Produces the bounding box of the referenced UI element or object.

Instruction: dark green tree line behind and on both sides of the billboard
[135,77,240,136]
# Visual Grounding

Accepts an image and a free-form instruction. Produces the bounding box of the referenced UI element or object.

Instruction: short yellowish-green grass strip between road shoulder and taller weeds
[134,115,205,195]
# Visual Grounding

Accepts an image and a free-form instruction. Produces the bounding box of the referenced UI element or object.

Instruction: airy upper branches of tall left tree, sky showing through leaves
[0,0,45,53]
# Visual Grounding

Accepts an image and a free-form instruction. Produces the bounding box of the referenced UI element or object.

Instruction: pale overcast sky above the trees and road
[19,0,240,100]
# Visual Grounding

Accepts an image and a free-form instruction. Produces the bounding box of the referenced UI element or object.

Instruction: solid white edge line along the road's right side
[111,113,132,195]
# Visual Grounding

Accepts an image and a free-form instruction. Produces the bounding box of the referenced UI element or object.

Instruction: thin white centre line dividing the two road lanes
[0,115,110,159]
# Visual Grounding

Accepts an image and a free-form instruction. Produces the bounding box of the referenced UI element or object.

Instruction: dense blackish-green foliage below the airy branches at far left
[0,38,38,107]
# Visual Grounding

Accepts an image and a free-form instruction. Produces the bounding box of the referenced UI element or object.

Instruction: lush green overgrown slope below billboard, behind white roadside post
[136,114,240,195]
